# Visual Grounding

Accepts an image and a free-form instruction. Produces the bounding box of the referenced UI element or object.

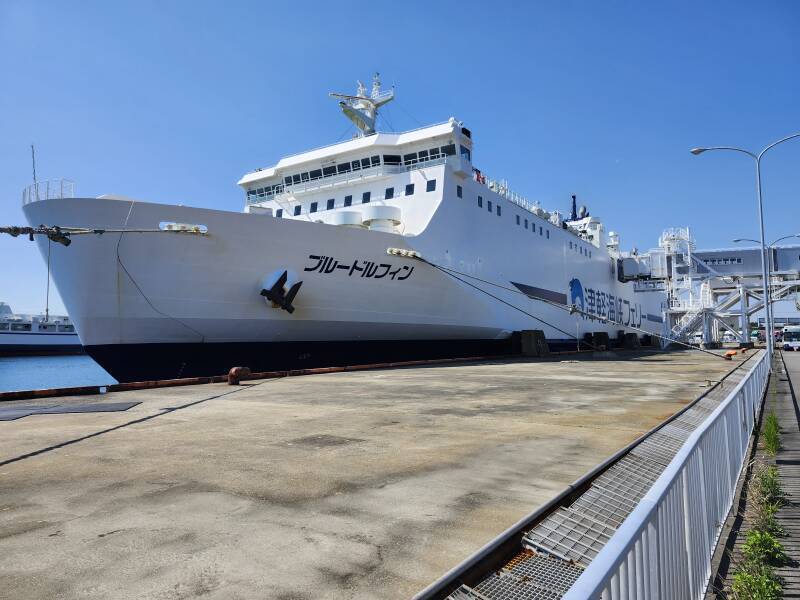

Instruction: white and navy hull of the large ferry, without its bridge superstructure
[24,186,662,381]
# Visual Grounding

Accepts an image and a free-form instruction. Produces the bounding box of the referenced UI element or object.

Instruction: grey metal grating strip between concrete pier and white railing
[448,356,749,600]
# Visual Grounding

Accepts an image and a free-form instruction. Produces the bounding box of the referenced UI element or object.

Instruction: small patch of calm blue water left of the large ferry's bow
[0,354,117,392]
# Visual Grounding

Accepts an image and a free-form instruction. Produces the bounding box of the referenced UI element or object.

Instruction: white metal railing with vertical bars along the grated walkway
[564,352,770,600]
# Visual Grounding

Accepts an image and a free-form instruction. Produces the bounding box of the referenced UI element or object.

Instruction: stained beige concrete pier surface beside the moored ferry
[0,351,741,600]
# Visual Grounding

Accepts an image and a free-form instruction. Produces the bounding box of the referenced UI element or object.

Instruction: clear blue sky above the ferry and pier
[0,0,800,311]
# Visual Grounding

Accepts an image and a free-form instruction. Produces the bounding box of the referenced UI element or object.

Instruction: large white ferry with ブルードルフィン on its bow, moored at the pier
[23,76,664,381]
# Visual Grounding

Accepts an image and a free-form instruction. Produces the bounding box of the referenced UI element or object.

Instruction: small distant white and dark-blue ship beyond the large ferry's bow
[0,302,82,356]
